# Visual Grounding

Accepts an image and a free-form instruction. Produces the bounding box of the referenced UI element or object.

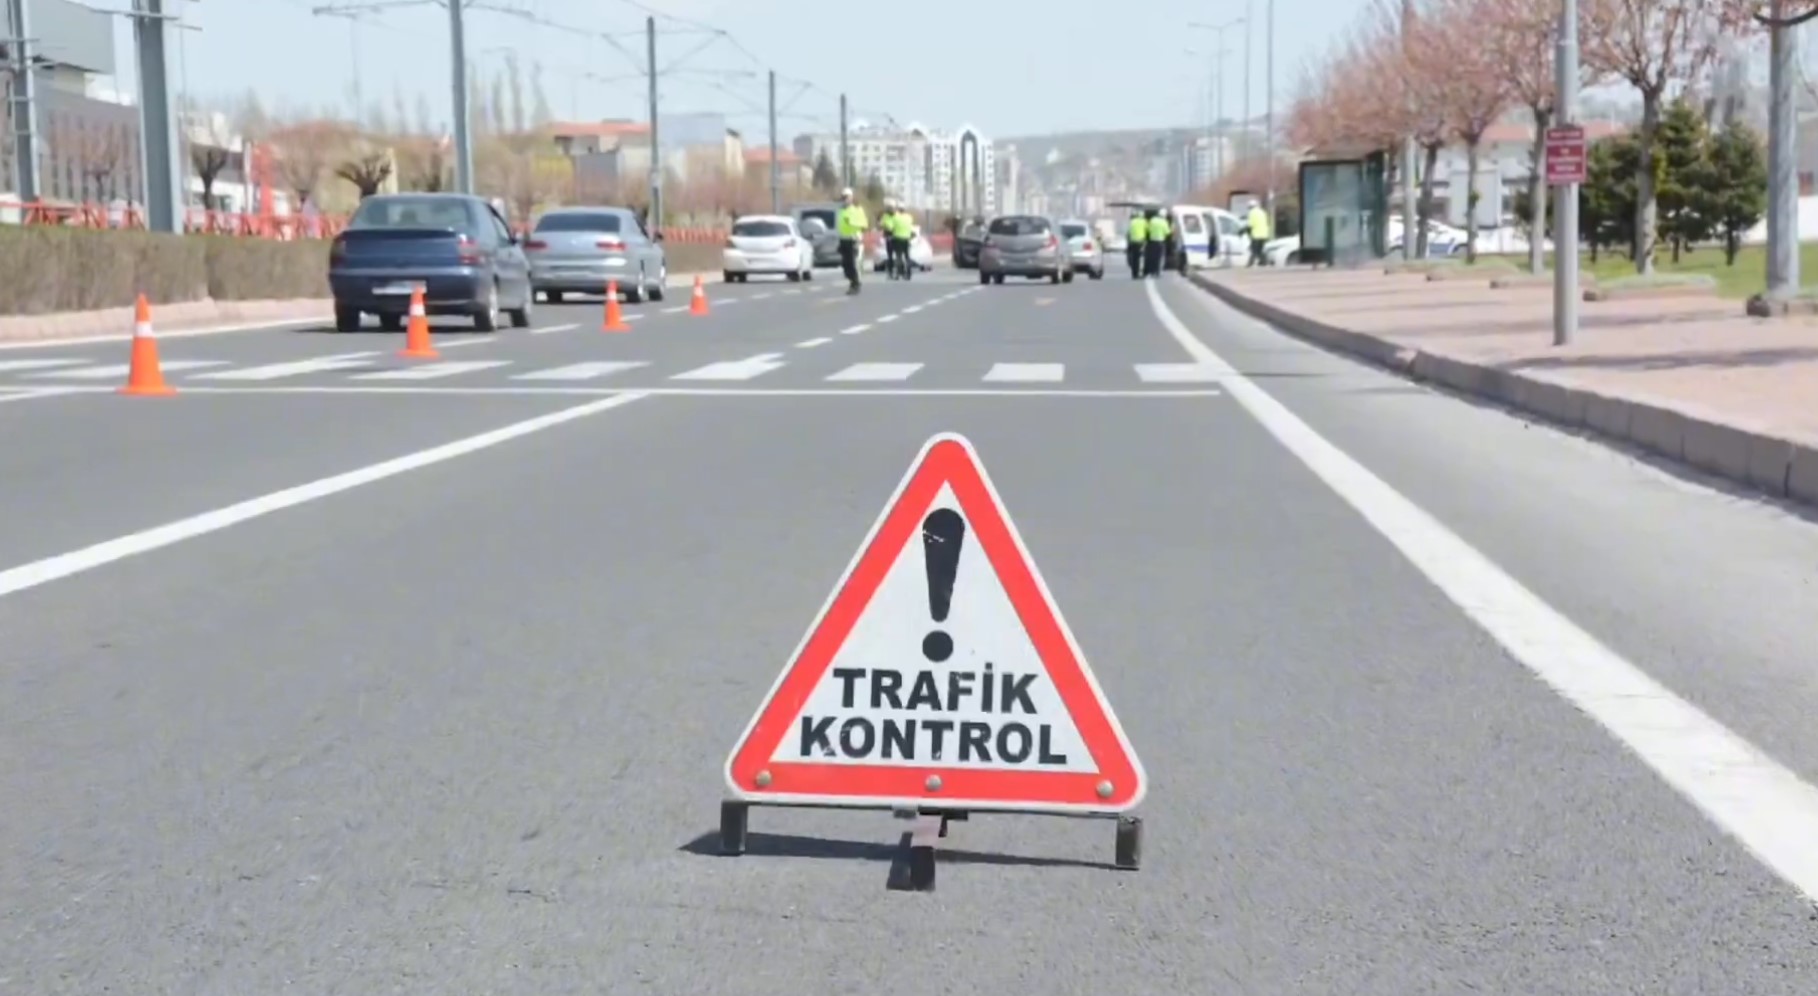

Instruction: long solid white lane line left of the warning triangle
[0,389,644,598]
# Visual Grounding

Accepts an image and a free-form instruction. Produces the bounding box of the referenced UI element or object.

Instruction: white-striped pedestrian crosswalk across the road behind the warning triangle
[0,351,1218,387]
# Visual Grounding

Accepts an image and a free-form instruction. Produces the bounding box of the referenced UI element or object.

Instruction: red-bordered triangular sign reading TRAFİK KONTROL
[725,434,1147,814]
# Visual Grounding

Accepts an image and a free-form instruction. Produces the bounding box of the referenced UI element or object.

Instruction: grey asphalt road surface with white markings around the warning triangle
[0,259,1818,996]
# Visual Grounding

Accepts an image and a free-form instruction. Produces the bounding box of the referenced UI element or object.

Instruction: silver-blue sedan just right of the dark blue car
[524,207,669,304]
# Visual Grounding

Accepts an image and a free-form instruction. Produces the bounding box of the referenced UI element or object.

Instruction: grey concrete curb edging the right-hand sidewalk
[1189,274,1818,505]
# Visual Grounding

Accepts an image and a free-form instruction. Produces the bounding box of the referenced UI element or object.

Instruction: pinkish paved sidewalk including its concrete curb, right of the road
[1193,269,1818,505]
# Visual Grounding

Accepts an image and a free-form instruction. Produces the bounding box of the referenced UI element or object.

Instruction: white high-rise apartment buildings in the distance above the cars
[794,122,1002,214]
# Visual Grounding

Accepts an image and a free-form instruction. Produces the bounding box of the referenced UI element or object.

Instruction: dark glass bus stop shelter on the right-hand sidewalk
[1300,147,1389,265]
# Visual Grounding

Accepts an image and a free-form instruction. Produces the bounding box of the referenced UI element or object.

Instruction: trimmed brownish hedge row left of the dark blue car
[0,225,329,314]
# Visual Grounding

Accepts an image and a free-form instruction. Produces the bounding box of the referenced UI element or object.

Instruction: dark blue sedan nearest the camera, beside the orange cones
[329,193,534,333]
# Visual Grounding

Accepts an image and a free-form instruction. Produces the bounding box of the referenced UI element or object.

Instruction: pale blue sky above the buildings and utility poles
[85,0,1367,144]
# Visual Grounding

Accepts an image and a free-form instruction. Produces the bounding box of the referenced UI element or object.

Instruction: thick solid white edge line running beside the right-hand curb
[1144,282,1818,901]
